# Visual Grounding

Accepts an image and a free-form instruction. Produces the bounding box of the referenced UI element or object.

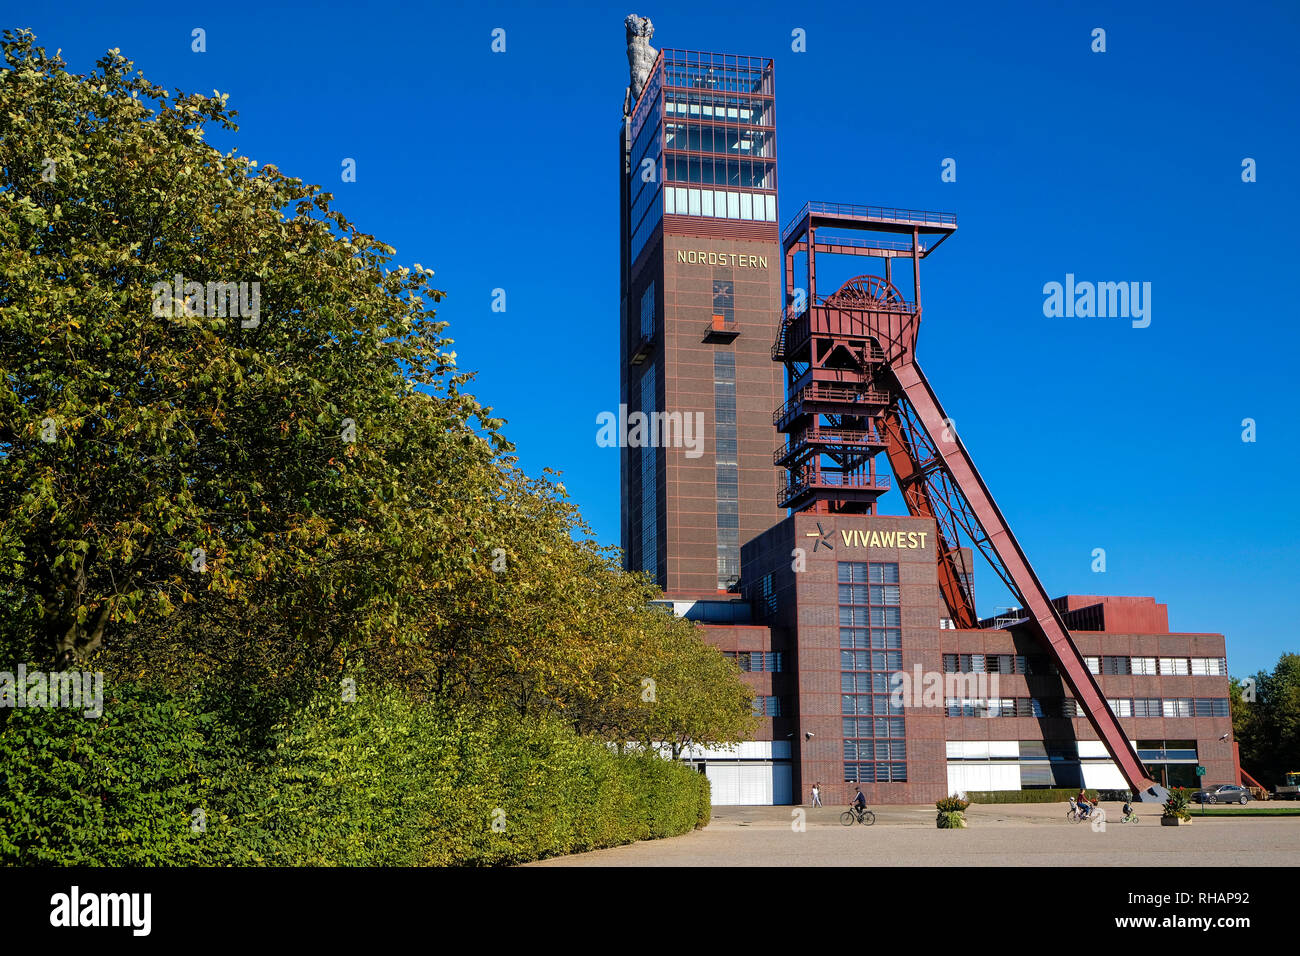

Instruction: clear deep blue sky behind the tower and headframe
[20,0,1300,675]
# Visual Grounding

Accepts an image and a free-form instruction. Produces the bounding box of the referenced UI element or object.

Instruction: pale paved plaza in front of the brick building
[532,804,1300,868]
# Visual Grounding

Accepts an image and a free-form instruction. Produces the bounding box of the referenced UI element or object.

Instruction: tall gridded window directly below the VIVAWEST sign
[839,561,907,783]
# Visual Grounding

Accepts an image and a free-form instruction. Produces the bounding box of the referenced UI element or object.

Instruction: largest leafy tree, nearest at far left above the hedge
[0,31,503,661]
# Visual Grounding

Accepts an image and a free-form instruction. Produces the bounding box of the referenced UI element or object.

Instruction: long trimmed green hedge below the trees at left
[0,691,710,866]
